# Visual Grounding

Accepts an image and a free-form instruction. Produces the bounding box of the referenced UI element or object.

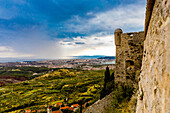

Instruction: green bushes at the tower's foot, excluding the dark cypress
[108,71,143,113]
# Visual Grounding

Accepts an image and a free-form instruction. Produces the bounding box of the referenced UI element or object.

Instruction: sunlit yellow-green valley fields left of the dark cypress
[0,67,111,112]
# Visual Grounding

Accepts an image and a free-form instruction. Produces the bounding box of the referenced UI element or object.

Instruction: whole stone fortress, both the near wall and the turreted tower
[83,0,170,113]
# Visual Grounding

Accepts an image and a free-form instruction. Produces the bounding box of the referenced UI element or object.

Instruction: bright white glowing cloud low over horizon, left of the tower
[59,34,115,56]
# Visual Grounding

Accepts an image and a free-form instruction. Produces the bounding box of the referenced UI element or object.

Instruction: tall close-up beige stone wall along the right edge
[137,0,170,113]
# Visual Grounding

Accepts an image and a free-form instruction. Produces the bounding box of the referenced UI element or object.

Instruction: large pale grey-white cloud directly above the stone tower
[67,4,145,33]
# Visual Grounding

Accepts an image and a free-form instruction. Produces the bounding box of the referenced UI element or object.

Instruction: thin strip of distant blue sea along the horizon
[0,55,115,63]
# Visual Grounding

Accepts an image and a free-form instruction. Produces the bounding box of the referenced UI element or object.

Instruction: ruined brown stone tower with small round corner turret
[114,28,144,82]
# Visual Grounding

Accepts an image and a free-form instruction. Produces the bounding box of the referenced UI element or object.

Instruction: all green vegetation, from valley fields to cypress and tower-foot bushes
[0,67,139,113]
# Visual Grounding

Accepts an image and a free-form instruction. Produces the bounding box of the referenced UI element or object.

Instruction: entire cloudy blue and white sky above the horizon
[0,0,146,59]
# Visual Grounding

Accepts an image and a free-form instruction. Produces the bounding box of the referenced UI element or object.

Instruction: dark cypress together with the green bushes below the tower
[94,67,138,113]
